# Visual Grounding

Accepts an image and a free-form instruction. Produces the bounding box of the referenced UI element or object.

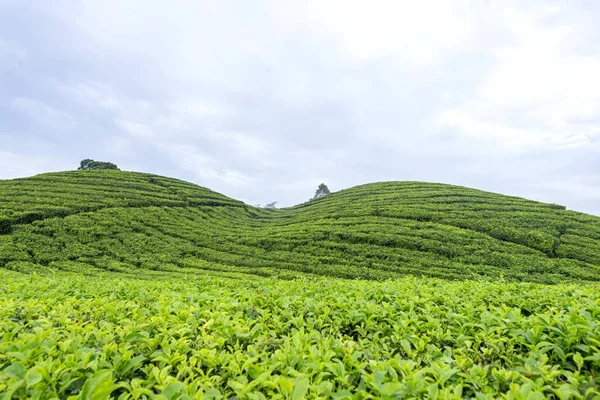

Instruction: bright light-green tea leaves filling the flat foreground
[0,270,600,399]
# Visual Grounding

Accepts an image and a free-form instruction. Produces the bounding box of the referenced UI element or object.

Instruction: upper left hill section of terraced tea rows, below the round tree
[0,171,243,234]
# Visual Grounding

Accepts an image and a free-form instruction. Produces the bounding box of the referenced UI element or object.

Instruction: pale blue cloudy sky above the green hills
[0,0,600,215]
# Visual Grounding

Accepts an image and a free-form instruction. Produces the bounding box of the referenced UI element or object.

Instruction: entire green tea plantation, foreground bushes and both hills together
[0,171,600,399]
